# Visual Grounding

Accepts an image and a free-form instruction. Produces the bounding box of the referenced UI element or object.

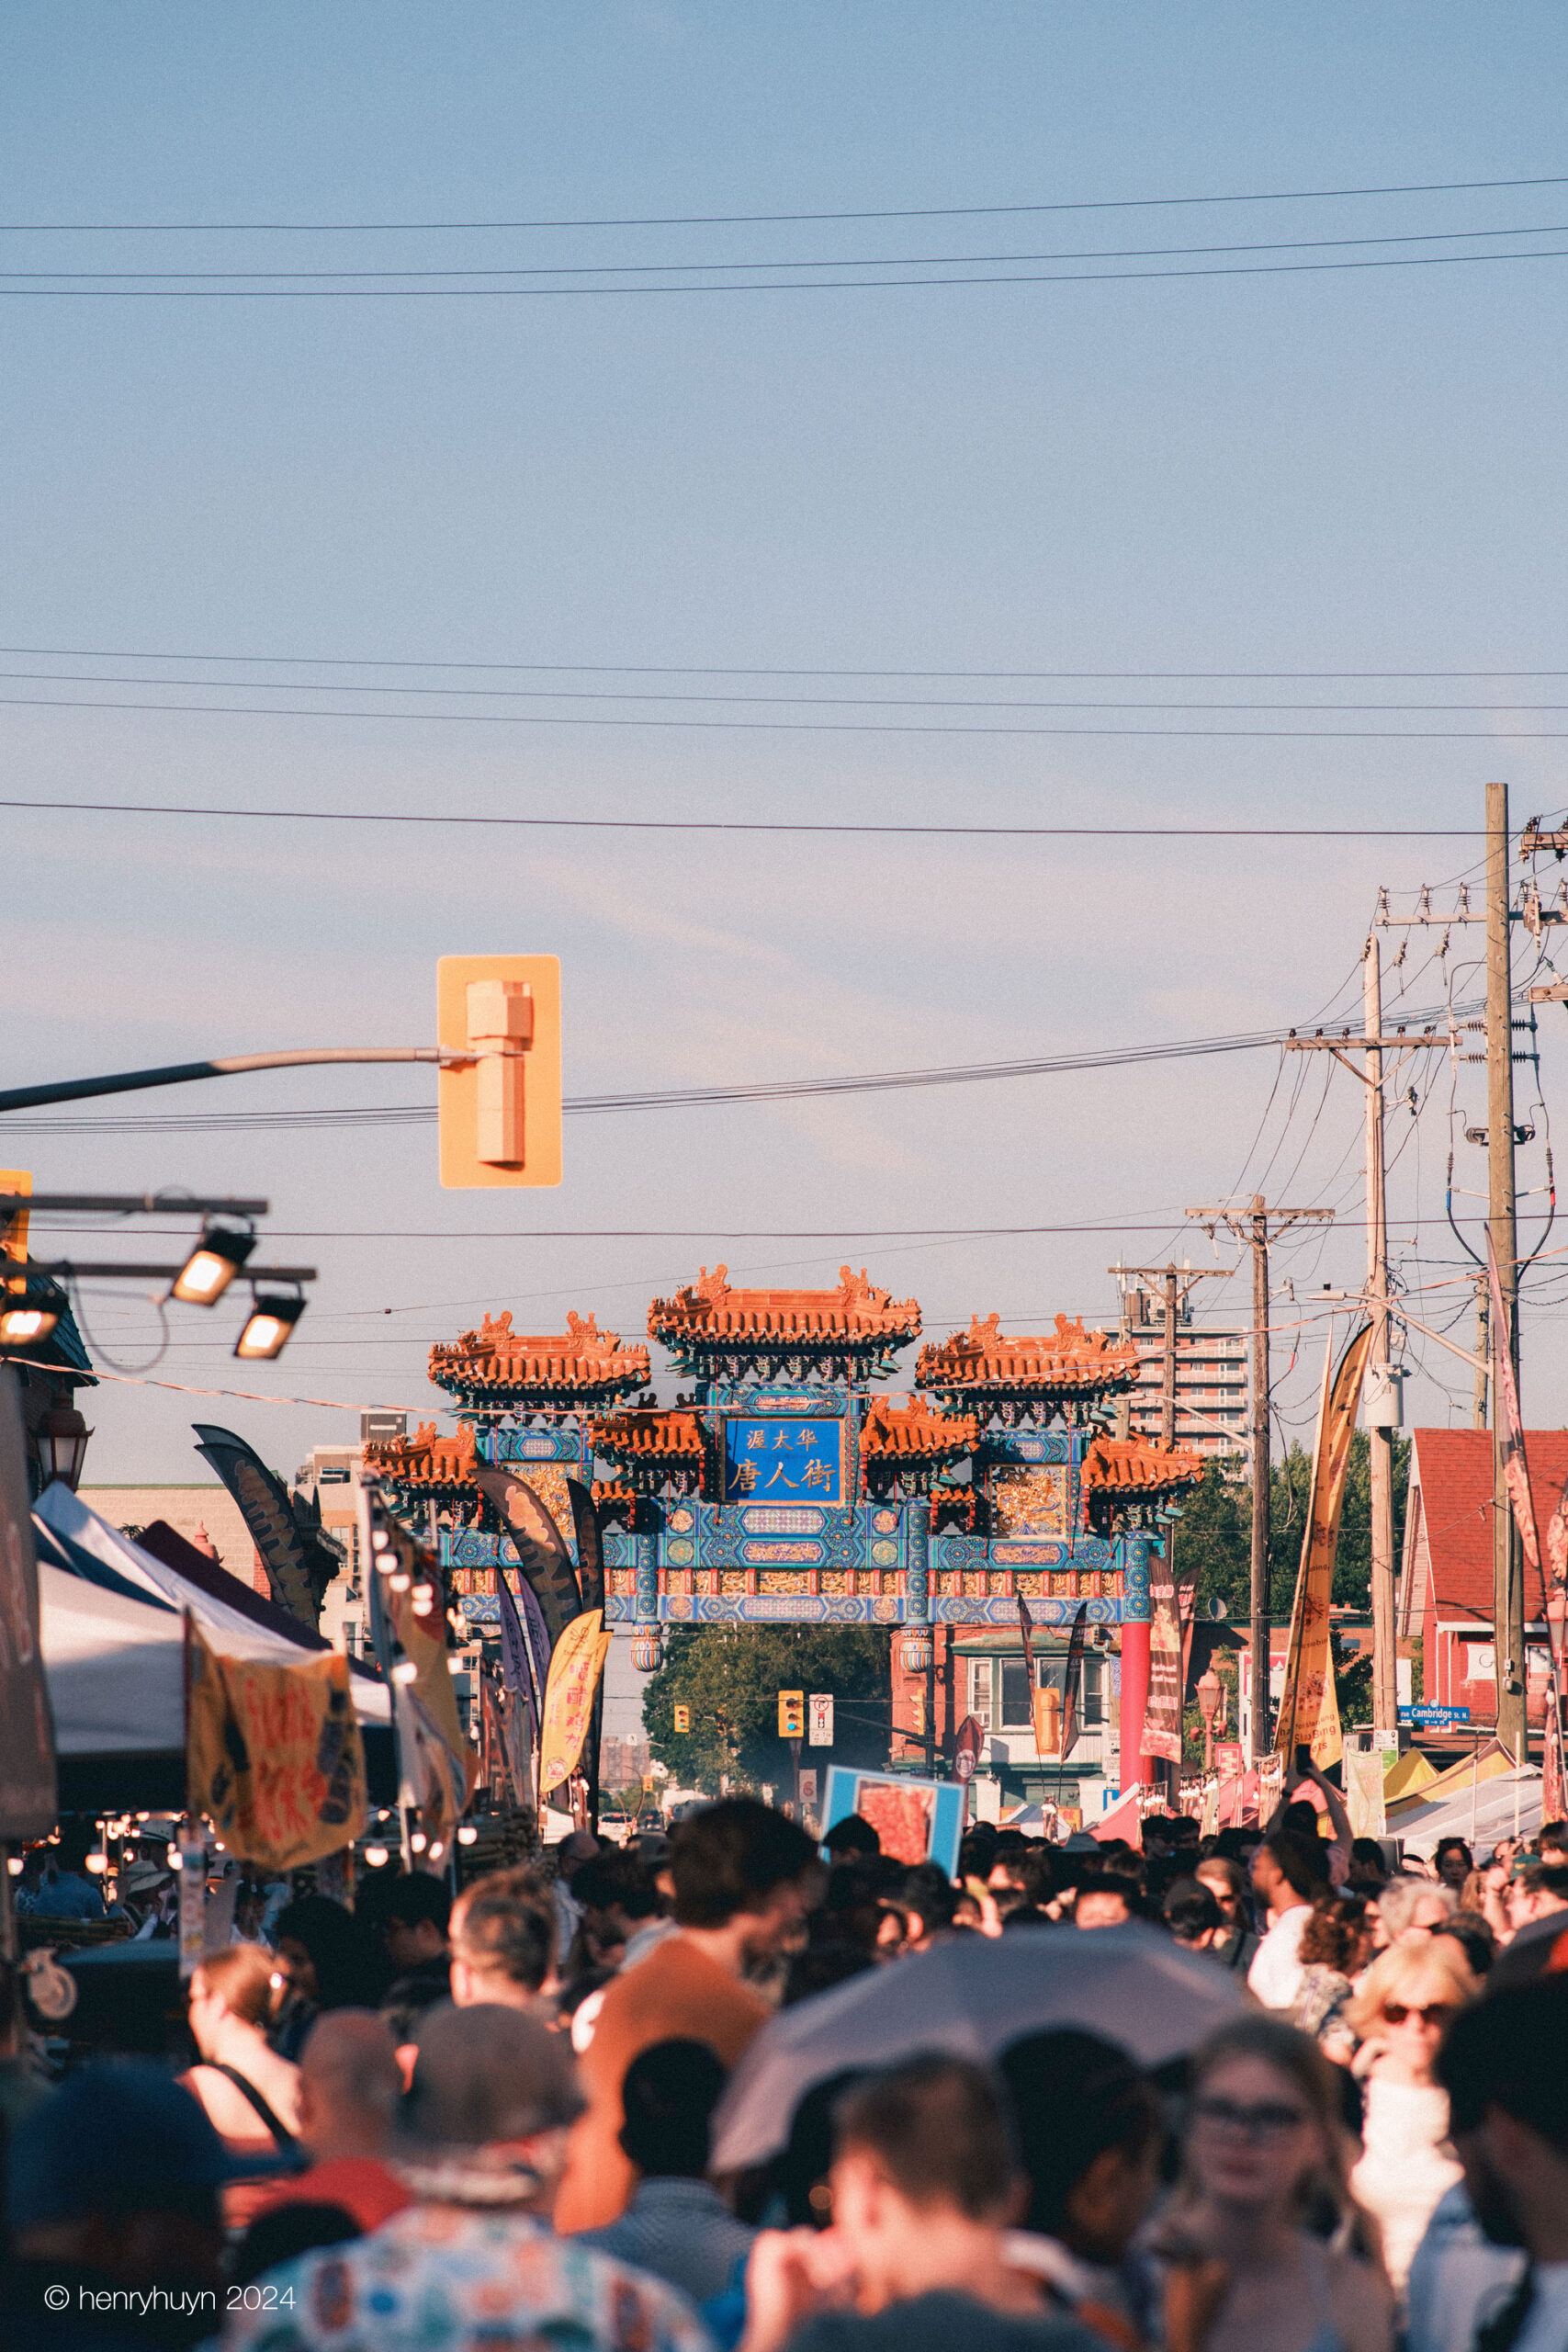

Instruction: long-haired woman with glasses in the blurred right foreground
[1156,2016,1392,2352]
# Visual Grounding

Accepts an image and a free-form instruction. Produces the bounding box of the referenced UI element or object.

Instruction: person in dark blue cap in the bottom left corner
[0,2058,272,2352]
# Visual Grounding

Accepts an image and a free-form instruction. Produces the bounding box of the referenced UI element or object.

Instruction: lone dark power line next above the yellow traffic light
[0,790,1491,842]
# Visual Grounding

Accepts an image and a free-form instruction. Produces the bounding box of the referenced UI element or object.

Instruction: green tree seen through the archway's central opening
[642,1625,891,1794]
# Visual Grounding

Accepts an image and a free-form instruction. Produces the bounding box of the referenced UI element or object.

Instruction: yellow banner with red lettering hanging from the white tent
[186,1611,367,1870]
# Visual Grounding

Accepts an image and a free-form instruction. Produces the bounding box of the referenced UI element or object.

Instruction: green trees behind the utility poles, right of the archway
[1176,1430,1411,1623]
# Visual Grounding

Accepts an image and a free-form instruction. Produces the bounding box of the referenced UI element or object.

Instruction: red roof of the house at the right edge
[1401,1430,1568,1633]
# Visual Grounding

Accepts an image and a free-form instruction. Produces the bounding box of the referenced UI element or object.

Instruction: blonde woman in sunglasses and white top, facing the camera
[1345,1936,1479,2296]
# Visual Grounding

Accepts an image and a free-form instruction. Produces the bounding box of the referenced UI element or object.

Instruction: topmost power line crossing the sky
[0,176,1568,238]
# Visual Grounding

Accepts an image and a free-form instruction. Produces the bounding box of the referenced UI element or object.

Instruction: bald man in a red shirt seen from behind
[250,2008,413,2230]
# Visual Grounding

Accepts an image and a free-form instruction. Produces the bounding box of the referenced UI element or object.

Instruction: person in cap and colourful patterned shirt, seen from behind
[221,2004,710,2352]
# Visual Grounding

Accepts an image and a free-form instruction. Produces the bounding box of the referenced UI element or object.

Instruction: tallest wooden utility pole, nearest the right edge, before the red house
[1485,783,1526,1764]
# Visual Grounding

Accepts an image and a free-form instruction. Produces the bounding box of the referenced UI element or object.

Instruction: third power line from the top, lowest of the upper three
[0,231,1568,301]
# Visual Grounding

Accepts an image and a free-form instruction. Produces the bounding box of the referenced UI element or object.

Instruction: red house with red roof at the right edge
[1399,1430,1568,1724]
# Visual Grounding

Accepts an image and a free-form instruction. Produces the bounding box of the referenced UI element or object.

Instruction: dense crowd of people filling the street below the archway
[0,1773,1568,2352]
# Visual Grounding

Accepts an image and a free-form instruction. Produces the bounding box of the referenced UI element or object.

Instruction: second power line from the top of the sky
[12,221,1568,285]
